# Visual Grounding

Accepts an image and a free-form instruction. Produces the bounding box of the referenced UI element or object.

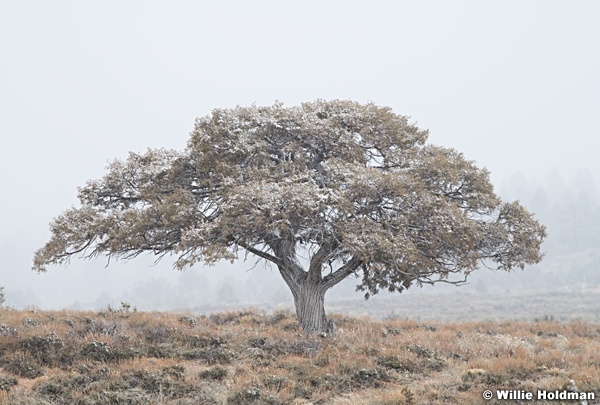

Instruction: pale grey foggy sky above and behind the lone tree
[0,1,600,307]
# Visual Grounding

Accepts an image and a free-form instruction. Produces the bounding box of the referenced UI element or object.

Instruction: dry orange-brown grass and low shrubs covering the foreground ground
[0,307,600,405]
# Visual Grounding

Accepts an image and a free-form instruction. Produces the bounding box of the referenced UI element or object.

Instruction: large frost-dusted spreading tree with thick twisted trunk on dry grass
[33,100,545,332]
